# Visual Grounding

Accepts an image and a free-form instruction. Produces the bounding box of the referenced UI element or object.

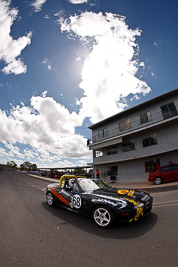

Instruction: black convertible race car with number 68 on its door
[45,175,153,228]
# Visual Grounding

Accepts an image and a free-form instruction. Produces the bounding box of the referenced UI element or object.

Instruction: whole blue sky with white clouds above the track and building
[0,0,178,167]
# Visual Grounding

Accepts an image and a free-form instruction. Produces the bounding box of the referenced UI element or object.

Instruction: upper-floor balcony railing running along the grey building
[87,106,178,146]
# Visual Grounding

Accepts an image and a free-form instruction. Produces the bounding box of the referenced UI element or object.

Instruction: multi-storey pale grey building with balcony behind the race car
[88,88,178,182]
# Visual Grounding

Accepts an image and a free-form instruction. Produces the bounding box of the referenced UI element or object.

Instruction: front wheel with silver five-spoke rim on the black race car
[93,206,114,228]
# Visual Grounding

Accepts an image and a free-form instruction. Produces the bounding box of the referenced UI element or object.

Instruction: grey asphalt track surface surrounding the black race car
[0,171,178,267]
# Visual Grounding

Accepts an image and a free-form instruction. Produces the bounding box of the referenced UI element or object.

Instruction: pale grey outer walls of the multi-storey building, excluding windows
[89,91,178,182]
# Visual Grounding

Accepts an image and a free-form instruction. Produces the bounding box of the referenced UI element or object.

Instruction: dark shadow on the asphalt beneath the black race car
[42,202,158,239]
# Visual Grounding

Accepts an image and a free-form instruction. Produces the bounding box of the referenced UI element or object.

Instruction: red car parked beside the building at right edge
[148,163,178,185]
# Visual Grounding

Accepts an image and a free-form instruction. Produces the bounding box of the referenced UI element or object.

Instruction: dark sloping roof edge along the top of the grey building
[88,88,178,130]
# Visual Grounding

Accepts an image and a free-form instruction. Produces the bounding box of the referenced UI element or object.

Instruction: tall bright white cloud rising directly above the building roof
[59,12,151,123]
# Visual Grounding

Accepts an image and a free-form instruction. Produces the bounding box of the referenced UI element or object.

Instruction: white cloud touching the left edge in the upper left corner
[0,1,32,75]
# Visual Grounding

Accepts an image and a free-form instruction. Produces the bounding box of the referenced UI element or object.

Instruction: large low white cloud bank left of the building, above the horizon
[0,92,91,164]
